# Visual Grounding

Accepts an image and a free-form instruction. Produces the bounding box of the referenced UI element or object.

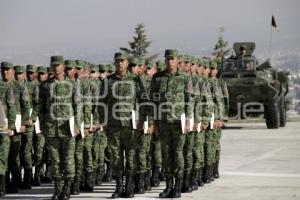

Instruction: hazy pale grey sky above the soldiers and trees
[0,0,300,64]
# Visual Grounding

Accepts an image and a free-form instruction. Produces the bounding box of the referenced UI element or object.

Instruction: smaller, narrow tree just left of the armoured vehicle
[212,26,231,63]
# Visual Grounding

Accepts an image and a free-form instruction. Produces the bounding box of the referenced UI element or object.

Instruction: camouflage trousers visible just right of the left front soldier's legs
[74,134,83,180]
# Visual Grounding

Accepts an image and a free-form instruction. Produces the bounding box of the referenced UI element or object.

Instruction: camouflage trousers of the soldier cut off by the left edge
[0,134,10,175]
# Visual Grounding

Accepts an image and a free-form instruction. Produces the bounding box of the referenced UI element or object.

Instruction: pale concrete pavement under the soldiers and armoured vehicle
[6,122,300,200]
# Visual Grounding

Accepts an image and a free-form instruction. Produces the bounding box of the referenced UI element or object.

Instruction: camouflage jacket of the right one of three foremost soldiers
[150,70,193,123]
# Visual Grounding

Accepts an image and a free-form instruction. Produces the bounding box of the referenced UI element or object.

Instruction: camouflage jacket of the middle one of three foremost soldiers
[98,72,146,127]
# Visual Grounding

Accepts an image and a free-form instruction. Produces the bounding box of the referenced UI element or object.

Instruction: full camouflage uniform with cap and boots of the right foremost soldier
[150,50,193,197]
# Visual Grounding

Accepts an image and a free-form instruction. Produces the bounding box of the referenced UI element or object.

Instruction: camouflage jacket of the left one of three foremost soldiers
[39,77,82,137]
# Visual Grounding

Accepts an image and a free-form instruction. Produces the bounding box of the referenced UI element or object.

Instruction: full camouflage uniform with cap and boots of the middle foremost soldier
[99,52,145,198]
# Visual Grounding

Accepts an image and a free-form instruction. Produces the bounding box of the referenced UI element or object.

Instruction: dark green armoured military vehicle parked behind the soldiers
[220,42,289,129]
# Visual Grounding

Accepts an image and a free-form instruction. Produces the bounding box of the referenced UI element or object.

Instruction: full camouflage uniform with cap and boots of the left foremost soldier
[39,56,81,199]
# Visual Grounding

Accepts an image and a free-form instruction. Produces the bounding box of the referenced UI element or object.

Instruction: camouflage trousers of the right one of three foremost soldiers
[159,122,185,178]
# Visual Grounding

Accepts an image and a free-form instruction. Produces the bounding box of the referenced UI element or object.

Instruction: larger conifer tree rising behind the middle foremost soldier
[120,23,151,57]
